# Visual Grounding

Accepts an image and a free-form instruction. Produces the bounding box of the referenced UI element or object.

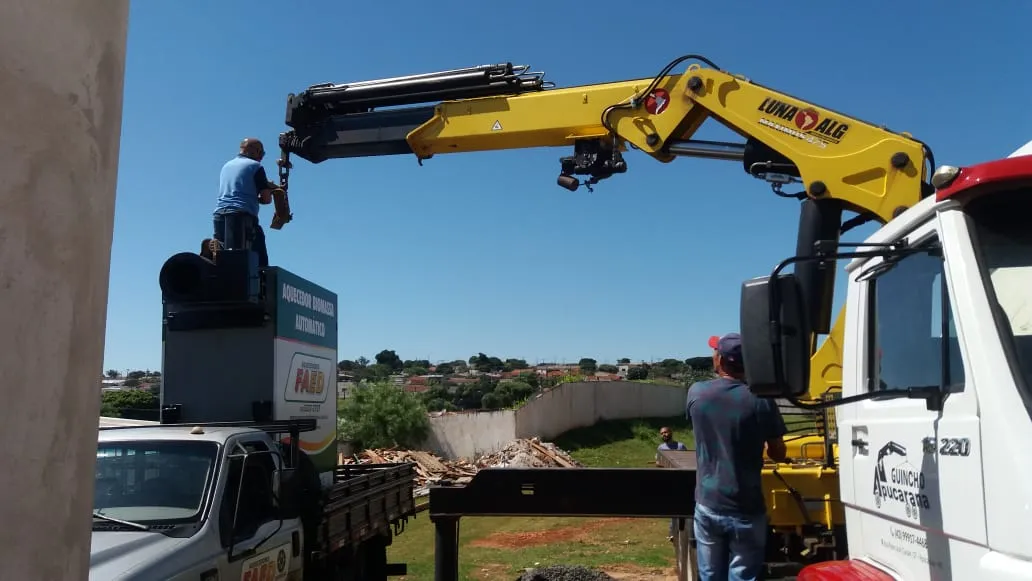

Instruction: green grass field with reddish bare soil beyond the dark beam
[388,418,691,581]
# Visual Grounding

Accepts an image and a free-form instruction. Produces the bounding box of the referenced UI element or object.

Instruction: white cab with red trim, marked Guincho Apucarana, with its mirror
[742,144,1032,581]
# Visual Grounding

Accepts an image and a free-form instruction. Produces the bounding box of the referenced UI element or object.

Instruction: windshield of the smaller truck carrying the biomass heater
[93,441,218,525]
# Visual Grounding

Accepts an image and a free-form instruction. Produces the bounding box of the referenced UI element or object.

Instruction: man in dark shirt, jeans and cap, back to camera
[686,333,785,581]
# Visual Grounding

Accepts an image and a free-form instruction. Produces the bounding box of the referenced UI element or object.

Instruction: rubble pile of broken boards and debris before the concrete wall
[338,438,581,496]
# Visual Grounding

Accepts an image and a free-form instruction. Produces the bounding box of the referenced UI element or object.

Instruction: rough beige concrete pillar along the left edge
[0,0,129,581]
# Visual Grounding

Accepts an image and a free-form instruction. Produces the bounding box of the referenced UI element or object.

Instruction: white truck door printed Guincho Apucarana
[839,220,986,580]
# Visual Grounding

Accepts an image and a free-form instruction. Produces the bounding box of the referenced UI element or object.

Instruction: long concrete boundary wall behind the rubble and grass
[423,381,686,458]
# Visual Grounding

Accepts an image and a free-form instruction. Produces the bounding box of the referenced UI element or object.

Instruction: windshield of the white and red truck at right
[965,188,1032,396]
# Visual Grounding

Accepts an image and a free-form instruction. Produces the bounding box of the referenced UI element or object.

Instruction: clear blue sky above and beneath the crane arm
[104,0,1032,369]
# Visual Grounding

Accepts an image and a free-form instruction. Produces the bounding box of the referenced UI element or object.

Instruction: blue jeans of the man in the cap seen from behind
[694,504,767,581]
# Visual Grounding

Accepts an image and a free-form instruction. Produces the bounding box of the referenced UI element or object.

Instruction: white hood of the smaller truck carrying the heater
[90,530,190,581]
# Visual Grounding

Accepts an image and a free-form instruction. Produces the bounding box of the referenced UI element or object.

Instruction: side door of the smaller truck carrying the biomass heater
[219,438,301,581]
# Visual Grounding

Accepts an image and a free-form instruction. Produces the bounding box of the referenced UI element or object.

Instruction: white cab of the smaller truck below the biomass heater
[90,425,302,581]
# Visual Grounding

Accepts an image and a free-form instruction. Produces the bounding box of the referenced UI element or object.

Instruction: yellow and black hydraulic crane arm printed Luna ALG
[279,55,935,398]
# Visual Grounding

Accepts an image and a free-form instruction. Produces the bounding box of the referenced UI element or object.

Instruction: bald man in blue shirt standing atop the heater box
[214,137,277,266]
